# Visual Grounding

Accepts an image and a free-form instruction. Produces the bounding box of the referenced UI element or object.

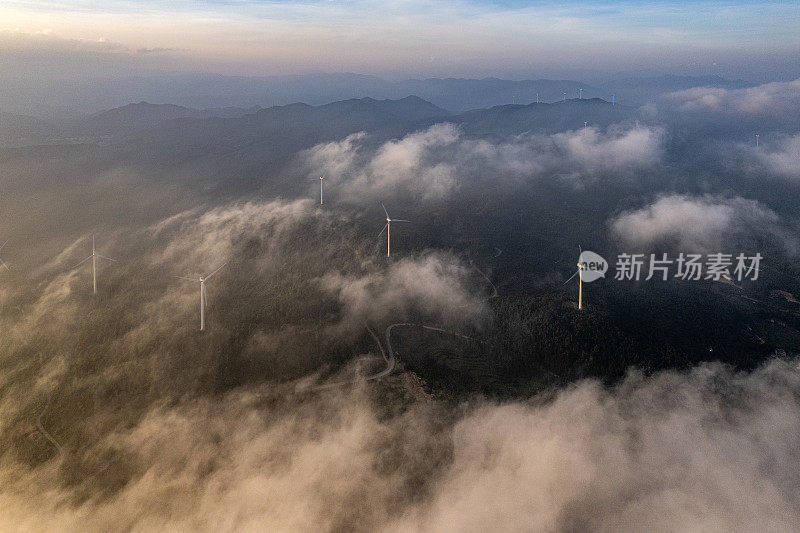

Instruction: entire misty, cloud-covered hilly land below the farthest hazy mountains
[0,74,800,531]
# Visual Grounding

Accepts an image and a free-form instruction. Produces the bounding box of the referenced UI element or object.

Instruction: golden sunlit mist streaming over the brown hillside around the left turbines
[0,193,485,467]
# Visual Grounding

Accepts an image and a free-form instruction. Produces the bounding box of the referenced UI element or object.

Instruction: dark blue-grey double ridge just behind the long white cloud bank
[130,96,635,156]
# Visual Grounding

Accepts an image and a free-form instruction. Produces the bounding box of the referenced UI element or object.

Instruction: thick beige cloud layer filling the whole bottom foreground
[0,360,800,531]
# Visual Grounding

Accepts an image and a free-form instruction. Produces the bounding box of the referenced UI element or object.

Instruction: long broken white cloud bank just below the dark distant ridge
[300,123,664,202]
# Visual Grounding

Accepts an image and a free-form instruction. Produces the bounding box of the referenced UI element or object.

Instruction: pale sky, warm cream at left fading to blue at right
[0,0,800,81]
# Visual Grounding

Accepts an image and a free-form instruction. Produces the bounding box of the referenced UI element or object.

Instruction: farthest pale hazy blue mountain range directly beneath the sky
[0,73,747,118]
